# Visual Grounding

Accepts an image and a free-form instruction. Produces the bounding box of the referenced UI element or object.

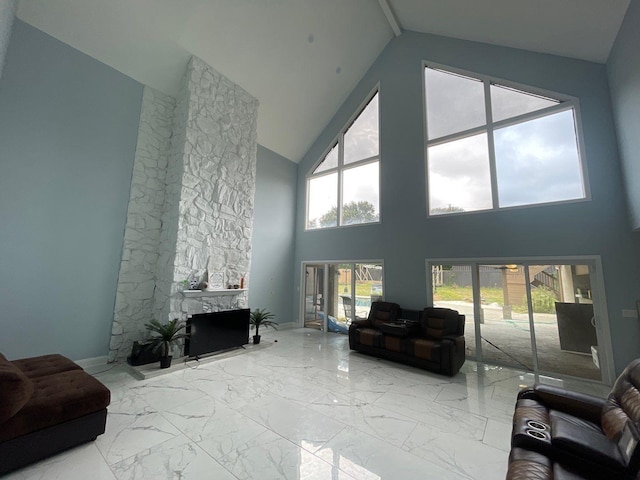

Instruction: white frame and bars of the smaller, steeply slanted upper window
[304,83,382,232]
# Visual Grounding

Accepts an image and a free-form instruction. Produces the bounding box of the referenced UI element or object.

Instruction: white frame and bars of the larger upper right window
[422,60,591,218]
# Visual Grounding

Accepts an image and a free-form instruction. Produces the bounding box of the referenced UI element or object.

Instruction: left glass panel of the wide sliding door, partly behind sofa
[431,265,478,359]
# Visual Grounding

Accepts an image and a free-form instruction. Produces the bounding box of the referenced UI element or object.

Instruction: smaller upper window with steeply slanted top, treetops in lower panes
[307,91,380,229]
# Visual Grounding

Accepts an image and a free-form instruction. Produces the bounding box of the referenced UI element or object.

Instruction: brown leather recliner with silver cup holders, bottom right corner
[507,359,640,479]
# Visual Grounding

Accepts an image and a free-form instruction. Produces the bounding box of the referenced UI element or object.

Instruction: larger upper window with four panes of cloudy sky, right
[425,66,587,215]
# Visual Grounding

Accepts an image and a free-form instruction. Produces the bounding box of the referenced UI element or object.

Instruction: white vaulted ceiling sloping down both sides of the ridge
[17,0,630,162]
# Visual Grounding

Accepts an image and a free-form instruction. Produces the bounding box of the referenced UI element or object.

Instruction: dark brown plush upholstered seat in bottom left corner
[0,353,111,475]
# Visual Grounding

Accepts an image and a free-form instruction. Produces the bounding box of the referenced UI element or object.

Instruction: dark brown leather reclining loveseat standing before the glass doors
[349,302,465,376]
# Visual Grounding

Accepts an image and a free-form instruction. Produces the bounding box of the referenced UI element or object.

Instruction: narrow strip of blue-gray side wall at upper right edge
[607,0,640,230]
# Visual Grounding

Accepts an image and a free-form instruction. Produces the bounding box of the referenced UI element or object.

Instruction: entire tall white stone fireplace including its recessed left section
[109,57,258,361]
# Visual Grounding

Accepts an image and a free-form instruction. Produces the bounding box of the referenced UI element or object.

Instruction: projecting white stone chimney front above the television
[165,57,258,318]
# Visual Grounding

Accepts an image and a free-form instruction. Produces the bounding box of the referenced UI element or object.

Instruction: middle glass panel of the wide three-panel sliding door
[478,264,534,370]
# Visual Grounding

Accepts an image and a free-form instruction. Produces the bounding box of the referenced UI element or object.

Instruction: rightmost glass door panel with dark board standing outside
[528,265,602,380]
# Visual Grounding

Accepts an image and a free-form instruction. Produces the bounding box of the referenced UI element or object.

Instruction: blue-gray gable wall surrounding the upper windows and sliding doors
[293,32,640,371]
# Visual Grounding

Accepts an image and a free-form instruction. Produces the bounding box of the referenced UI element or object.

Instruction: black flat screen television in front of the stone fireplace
[184,308,251,358]
